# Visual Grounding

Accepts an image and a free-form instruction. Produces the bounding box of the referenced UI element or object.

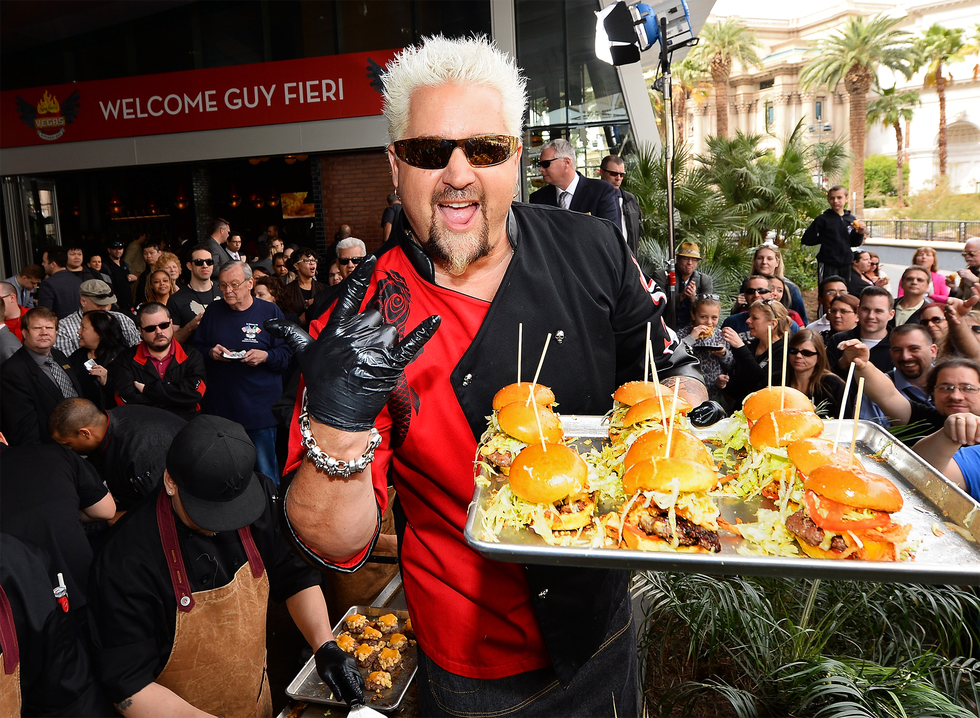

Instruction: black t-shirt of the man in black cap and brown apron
[89,476,320,703]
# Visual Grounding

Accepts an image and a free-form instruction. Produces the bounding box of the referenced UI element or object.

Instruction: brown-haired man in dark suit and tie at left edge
[0,307,81,446]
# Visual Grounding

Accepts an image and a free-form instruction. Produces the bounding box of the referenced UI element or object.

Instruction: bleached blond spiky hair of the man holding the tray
[382,35,527,141]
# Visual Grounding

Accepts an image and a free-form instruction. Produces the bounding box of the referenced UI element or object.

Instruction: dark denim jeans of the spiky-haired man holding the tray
[418,599,639,718]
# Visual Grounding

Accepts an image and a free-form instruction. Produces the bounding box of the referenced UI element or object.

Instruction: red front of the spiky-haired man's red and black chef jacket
[287,250,551,678]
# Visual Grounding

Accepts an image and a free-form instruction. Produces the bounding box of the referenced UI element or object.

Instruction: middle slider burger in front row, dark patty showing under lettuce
[620,457,721,553]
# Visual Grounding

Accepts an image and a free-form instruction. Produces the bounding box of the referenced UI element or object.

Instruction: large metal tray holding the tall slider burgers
[464,415,980,585]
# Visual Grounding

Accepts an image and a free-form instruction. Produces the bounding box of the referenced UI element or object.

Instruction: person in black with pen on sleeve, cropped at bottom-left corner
[0,533,115,718]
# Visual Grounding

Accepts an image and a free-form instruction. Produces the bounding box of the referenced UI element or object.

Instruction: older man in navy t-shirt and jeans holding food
[194,262,293,483]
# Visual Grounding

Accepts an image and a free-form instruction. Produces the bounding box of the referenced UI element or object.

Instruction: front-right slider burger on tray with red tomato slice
[786,463,912,561]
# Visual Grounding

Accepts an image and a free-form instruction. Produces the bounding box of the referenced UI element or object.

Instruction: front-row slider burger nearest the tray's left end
[509,442,595,537]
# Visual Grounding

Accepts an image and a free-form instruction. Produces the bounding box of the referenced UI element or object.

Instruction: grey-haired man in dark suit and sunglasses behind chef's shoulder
[530,139,621,222]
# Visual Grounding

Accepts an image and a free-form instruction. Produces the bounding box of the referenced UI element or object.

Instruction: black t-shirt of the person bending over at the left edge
[0,444,108,609]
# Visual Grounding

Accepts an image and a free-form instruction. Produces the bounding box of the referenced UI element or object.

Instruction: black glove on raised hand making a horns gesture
[265,257,441,431]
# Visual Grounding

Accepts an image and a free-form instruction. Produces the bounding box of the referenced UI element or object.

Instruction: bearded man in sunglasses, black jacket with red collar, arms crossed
[109,302,206,420]
